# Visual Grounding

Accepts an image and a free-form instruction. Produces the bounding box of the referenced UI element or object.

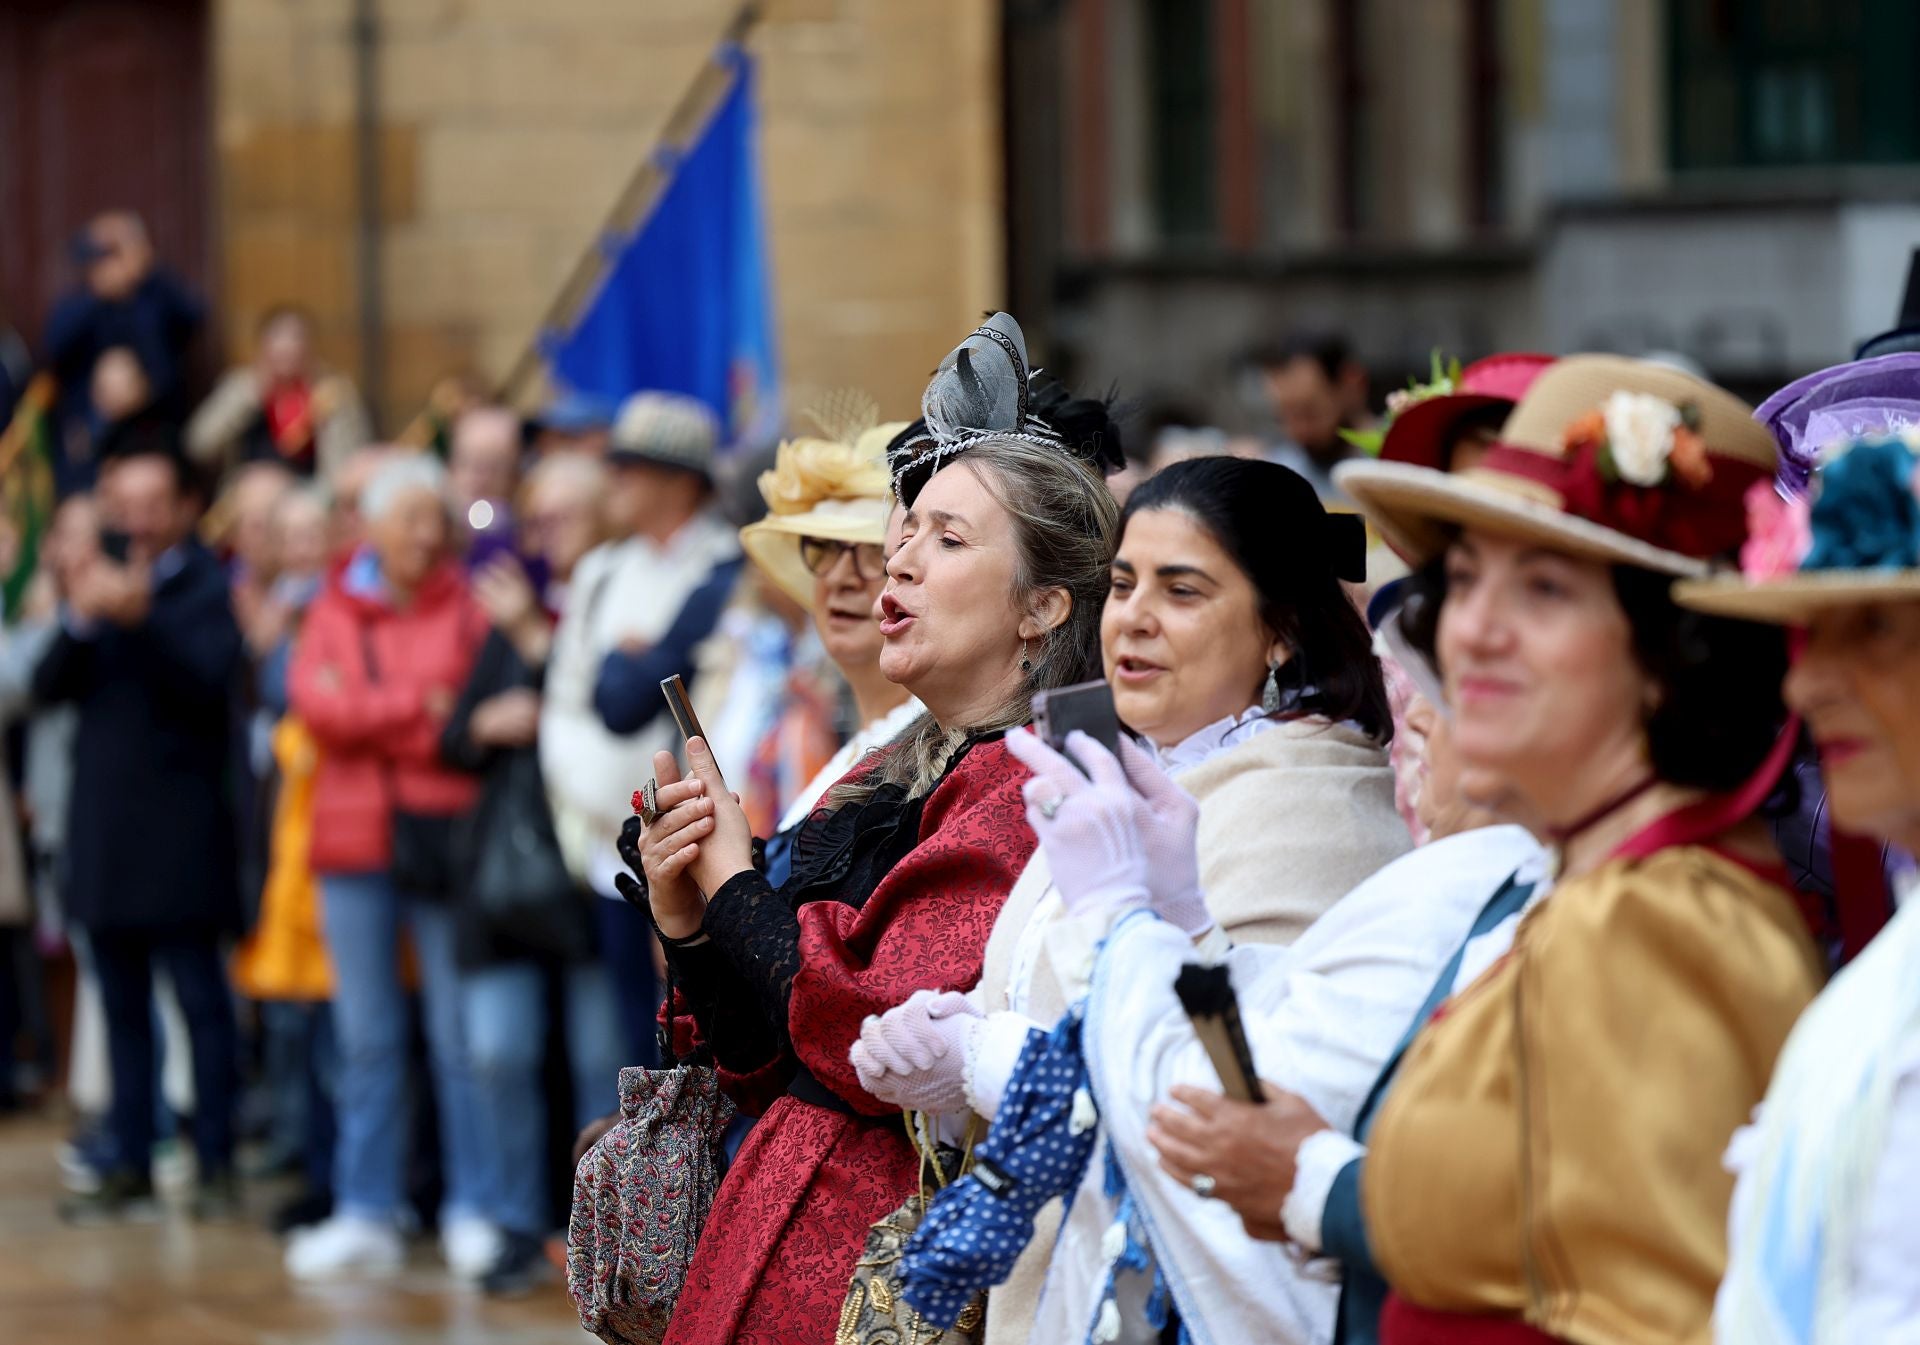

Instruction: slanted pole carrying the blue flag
[401,0,762,443]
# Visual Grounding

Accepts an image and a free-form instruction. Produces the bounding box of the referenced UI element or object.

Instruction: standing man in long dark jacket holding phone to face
[35,424,242,1218]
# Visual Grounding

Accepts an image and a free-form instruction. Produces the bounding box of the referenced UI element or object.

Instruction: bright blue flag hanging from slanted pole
[541,44,780,443]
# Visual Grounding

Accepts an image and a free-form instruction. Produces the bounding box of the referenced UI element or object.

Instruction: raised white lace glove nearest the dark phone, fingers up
[1006,729,1150,917]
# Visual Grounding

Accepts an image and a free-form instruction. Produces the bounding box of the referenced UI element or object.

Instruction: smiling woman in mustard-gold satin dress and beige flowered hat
[1320,357,1822,1345]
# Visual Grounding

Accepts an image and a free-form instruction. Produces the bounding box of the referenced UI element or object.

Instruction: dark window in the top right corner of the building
[1667,0,1920,171]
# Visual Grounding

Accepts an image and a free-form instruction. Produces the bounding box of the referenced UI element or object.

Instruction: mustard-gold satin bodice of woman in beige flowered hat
[1361,844,1824,1345]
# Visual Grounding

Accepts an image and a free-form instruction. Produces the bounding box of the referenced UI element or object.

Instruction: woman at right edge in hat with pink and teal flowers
[1676,355,1920,1345]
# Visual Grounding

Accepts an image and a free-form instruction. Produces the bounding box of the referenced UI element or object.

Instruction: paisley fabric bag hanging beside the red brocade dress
[566,1065,733,1345]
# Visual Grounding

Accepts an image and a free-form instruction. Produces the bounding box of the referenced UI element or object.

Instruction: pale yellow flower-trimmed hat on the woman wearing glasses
[739,395,906,608]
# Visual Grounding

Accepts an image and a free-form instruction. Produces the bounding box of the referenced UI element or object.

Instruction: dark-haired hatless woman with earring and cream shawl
[852,459,1407,1341]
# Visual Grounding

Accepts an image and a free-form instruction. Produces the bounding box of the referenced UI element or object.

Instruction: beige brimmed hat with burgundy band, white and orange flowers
[1334,355,1778,578]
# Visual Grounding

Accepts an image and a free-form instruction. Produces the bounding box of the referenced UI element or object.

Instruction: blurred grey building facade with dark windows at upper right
[1006,0,1920,424]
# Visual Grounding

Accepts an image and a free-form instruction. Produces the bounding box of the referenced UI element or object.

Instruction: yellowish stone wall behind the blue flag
[213,0,1004,430]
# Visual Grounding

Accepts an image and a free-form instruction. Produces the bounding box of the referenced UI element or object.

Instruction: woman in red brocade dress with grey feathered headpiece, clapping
[626,315,1117,1345]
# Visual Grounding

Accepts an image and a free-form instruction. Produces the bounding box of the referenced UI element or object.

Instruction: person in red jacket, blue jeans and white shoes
[286,457,499,1280]
